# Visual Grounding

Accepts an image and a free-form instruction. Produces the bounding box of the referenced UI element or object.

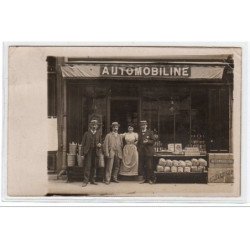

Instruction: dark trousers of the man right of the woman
[139,154,154,181]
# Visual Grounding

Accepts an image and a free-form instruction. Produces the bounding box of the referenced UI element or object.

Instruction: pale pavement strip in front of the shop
[48,176,237,197]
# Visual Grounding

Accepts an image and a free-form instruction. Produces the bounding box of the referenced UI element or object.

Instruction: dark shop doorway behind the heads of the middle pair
[110,99,140,133]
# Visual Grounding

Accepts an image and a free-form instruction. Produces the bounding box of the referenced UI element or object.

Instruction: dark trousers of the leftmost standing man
[83,148,96,183]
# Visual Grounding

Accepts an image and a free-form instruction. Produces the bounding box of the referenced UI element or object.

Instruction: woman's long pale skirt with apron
[120,144,138,176]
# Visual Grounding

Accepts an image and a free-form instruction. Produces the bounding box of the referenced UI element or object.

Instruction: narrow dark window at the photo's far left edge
[47,57,57,118]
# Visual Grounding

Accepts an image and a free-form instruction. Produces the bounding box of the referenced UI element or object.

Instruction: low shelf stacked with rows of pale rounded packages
[154,153,208,183]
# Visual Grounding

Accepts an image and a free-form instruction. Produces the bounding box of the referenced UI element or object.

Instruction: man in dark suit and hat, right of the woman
[137,121,155,184]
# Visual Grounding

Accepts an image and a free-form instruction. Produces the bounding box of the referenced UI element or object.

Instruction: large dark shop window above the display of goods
[142,86,208,151]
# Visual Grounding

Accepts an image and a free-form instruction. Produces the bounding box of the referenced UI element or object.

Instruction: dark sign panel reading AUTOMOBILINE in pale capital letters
[100,65,191,78]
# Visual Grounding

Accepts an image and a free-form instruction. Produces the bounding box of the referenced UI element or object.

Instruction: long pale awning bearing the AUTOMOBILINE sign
[61,62,226,79]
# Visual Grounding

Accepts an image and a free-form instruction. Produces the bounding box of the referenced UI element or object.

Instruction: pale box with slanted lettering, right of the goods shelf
[208,167,234,183]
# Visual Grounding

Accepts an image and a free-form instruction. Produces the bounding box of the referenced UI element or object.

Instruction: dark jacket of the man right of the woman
[137,130,155,156]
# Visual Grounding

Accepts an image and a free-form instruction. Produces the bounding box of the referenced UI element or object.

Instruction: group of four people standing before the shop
[82,120,155,187]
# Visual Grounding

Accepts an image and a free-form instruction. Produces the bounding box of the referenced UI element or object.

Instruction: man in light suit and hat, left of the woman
[103,122,123,185]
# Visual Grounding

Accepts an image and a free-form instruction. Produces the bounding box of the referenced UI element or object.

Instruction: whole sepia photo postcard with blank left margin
[2,45,242,201]
